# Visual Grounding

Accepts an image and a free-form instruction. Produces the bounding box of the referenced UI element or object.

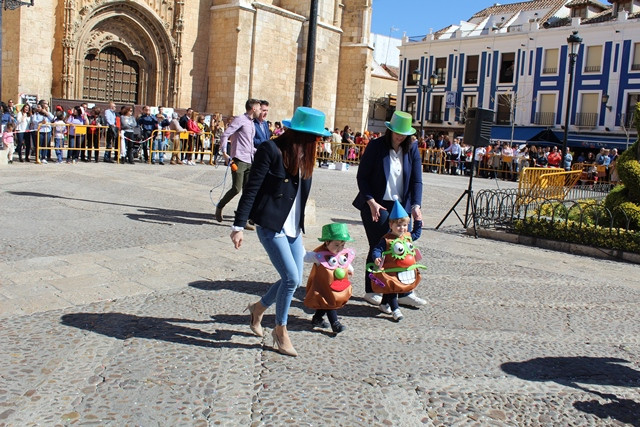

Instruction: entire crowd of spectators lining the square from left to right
[0,100,618,182]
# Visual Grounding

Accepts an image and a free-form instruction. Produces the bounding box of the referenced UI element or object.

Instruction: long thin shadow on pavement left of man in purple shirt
[8,191,212,225]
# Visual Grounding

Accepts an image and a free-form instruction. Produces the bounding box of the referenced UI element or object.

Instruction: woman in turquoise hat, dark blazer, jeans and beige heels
[231,107,330,356]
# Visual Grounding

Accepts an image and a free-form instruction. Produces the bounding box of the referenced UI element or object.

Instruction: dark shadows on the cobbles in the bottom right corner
[500,357,640,427]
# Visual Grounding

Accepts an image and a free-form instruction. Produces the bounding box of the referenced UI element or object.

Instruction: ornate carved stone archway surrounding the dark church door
[62,0,180,105]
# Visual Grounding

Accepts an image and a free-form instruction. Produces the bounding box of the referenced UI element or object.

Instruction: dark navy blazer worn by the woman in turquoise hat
[233,140,311,233]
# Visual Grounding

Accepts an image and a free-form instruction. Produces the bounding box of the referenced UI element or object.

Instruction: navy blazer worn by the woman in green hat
[353,135,422,213]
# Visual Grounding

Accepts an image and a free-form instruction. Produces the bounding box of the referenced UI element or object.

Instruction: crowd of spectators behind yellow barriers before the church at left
[0,100,225,166]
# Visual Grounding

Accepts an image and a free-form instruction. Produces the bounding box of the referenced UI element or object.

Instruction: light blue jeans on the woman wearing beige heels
[256,226,304,326]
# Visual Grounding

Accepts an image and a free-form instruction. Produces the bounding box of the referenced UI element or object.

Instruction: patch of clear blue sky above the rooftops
[371,0,522,38]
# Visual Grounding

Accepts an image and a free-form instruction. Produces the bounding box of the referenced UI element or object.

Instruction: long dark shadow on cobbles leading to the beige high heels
[60,313,262,349]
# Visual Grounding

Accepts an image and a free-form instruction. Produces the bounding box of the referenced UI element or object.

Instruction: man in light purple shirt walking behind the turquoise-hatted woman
[215,99,260,230]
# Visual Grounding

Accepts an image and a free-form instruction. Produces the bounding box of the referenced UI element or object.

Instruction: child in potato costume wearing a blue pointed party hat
[367,200,426,322]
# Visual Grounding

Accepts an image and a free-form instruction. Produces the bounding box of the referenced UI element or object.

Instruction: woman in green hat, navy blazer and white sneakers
[353,111,426,307]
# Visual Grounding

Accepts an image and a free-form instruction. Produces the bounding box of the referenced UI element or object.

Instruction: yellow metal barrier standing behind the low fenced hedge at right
[516,168,582,205]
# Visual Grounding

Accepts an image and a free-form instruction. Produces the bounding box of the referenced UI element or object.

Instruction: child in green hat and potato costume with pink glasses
[304,223,355,334]
